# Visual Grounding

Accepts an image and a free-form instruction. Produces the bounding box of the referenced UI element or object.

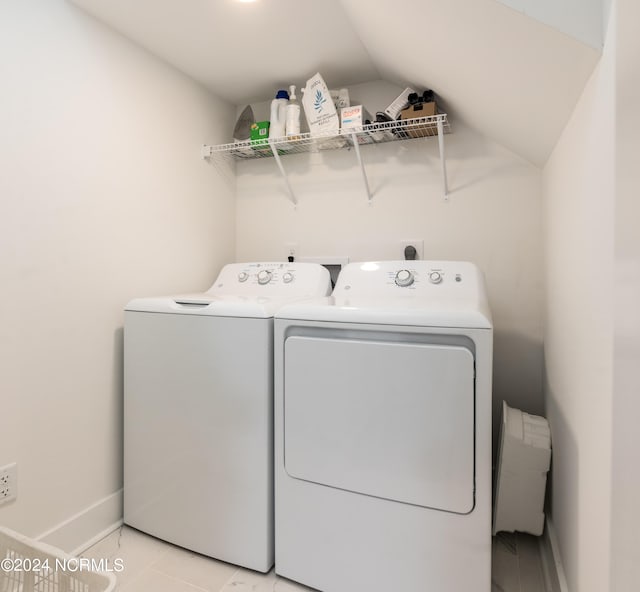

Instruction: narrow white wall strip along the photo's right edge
[610,0,640,592]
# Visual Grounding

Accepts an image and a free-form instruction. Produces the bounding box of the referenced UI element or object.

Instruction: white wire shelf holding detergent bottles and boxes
[203,113,451,160]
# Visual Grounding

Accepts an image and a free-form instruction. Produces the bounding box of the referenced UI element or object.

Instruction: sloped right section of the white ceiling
[342,0,600,166]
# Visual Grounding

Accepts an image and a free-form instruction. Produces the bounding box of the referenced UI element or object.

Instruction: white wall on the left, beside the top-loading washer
[0,0,235,549]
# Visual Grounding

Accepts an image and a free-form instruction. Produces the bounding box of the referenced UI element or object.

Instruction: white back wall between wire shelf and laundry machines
[236,82,543,440]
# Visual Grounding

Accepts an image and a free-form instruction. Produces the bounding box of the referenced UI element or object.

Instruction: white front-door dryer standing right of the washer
[274,261,493,592]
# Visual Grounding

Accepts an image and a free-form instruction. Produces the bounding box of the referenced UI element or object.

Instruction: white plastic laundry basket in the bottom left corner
[0,526,116,592]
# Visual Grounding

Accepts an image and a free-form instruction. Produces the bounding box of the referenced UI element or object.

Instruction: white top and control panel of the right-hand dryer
[276,261,492,329]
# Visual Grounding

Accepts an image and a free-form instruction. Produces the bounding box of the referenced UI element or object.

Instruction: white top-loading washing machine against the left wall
[124,263,330,572]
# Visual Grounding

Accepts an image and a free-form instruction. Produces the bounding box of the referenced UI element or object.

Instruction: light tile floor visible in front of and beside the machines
[83,526,546,592]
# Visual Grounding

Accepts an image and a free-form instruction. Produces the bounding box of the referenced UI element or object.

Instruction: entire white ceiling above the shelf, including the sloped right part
[72,0,600,166]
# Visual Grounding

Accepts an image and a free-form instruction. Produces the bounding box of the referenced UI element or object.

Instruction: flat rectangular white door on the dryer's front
[284,336,475,514]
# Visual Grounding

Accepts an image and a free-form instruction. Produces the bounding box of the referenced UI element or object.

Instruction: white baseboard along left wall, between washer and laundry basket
[36,489,122,555]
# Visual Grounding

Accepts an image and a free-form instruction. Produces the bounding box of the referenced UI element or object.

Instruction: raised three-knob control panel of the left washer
[207,262,331,298]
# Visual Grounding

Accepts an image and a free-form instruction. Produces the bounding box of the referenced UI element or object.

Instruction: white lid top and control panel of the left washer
[126,262,331,318]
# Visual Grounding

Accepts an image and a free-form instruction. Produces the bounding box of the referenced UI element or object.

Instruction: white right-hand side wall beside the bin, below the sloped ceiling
[543,9,615,592]
